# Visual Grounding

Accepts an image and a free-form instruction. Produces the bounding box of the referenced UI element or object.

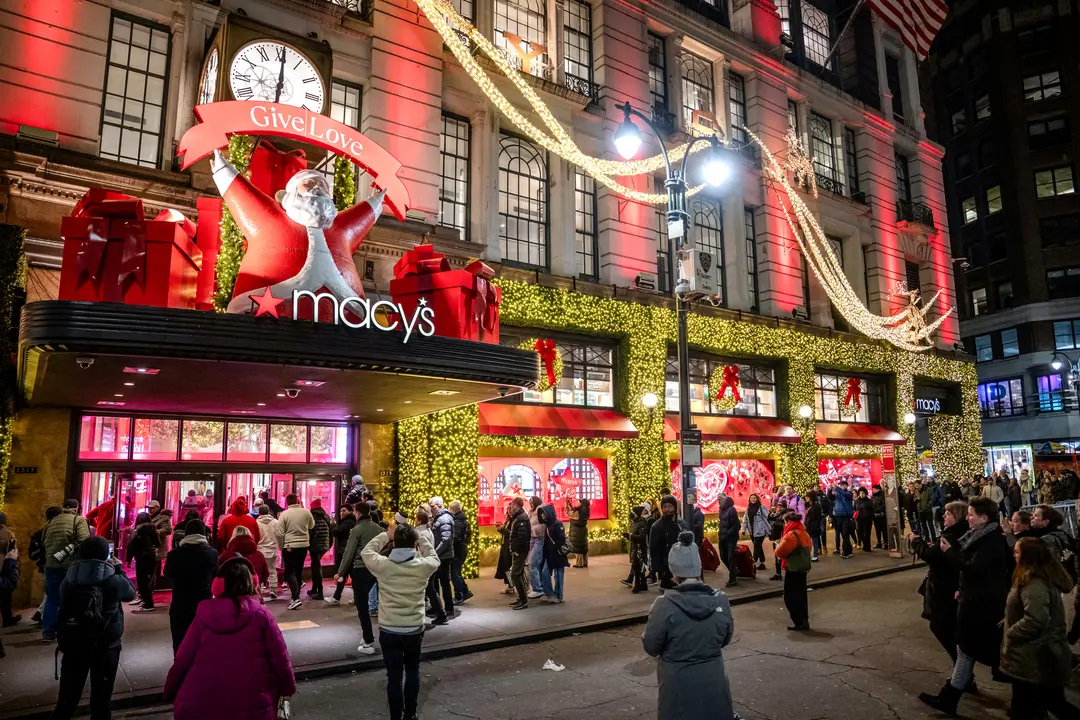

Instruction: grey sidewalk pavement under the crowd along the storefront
[0,543,912,718]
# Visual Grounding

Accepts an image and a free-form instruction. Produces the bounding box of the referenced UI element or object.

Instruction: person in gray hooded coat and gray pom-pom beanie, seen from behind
[642,530,737,720]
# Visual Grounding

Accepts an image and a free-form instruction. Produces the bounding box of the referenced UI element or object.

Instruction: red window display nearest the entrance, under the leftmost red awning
[478,458,608,527]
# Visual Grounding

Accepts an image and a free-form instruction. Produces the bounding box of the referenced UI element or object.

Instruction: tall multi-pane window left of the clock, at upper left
[97,10,173,169]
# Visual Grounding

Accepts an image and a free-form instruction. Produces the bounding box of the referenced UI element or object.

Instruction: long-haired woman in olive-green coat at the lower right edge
[1001,538,1080,720]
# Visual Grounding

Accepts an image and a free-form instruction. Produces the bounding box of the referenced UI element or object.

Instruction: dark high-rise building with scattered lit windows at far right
[924,0,1080,473]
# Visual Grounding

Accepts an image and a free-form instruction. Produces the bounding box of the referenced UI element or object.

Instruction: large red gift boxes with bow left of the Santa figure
[59,188,202,309]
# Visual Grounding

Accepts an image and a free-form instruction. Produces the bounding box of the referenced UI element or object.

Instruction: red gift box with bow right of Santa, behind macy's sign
[390,245,502,344]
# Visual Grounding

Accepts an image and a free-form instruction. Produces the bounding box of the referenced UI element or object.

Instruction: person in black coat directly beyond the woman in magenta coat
[165,519,217,655]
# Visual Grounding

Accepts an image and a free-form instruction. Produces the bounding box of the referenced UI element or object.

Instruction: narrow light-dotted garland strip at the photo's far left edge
[0,225,27,508]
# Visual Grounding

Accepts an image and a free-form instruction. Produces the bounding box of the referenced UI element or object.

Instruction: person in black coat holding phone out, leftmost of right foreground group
[907,501,975,692]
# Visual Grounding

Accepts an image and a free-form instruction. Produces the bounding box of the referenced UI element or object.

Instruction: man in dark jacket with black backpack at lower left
[50,535,135,720]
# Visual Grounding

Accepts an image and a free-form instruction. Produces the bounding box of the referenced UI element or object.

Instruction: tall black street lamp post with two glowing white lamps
[615,101,730,522]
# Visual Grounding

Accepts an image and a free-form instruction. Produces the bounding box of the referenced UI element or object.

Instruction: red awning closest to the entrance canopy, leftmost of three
[480,403,637,440]
